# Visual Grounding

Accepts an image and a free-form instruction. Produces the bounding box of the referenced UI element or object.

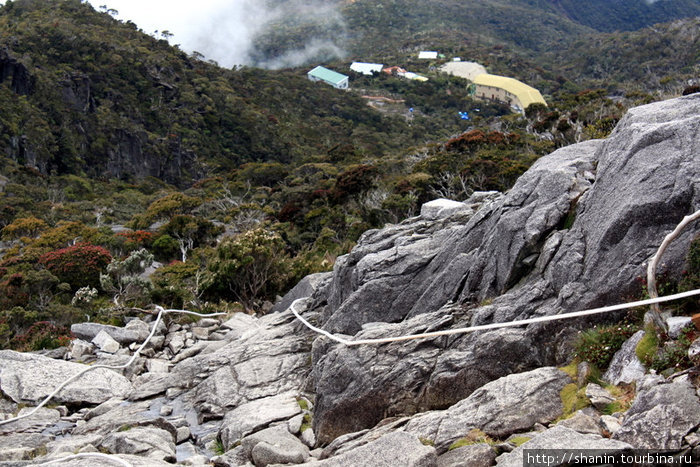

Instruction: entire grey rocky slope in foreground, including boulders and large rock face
[0,95,700,466]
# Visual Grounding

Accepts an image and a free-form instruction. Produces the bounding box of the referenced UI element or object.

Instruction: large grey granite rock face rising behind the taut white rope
[310,95,700,442]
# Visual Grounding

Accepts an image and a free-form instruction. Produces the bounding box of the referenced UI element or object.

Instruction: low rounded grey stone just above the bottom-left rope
[100,426,175,461]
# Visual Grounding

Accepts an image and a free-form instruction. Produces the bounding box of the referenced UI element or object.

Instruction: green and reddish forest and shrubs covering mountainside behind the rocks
[0,0,699,348]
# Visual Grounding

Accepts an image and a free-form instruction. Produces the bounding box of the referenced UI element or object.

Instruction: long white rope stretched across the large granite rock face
[290,289,700,347]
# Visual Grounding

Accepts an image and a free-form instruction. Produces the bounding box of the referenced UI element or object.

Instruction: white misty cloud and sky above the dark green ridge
[84,0,345,68]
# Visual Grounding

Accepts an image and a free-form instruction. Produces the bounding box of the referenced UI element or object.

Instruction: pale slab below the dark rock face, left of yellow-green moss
[405,367,571,452]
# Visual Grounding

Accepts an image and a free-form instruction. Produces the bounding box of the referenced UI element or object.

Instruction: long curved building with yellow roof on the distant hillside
[473,73,547,113]
